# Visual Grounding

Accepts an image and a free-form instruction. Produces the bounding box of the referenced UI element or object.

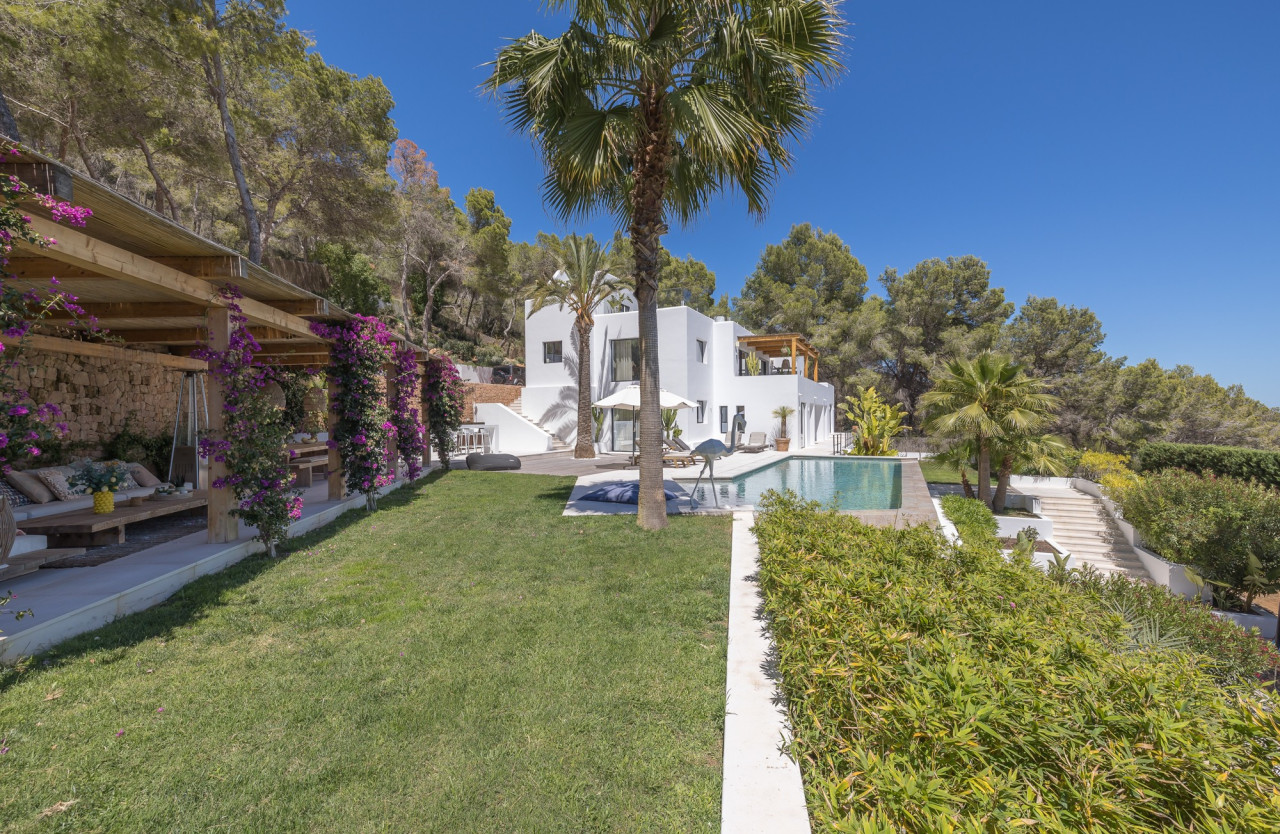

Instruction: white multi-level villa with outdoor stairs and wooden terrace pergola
[476,293,835,454]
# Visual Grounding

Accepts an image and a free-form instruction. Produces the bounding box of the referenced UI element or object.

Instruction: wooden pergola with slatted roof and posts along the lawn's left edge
[0,148,426,541]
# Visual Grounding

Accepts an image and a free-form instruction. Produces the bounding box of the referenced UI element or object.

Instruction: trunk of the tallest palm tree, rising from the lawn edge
[630,82,671,530]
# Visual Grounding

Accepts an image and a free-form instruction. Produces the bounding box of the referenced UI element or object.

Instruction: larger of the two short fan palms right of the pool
[920,353,1059,504]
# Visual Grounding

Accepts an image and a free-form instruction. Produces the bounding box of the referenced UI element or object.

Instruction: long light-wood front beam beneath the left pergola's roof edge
[19,217,320,342]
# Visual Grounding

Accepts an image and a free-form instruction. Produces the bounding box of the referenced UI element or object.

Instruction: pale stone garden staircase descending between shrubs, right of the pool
[1034,489,1151,579]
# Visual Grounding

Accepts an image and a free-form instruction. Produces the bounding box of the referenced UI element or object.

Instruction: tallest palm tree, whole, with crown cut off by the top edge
[486,0,844,530]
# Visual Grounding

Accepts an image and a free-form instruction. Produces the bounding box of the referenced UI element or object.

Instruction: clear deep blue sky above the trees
[289,0,1280,407]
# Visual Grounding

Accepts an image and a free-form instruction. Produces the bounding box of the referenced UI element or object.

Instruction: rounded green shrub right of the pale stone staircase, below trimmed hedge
[1117,469,1280,606]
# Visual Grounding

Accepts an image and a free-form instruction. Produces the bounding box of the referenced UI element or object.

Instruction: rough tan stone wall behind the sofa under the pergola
[18,350,182,446]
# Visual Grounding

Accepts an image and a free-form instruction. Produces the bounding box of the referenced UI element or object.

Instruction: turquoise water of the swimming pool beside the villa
[694,457,902,510]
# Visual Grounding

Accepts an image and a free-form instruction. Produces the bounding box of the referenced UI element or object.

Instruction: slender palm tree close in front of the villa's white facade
[530,234,622,458]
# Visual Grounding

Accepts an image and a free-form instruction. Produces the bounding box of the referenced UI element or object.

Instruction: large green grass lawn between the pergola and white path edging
[0,472,730,833]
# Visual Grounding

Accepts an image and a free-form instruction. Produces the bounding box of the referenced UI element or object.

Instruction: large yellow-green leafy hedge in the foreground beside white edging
[755,494,1280,833]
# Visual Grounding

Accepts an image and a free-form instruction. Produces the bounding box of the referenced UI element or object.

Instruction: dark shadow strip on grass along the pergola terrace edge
[0,472,443,693]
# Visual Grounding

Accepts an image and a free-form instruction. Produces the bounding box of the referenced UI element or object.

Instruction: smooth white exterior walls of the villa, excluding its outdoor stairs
[522,295,835,448]
